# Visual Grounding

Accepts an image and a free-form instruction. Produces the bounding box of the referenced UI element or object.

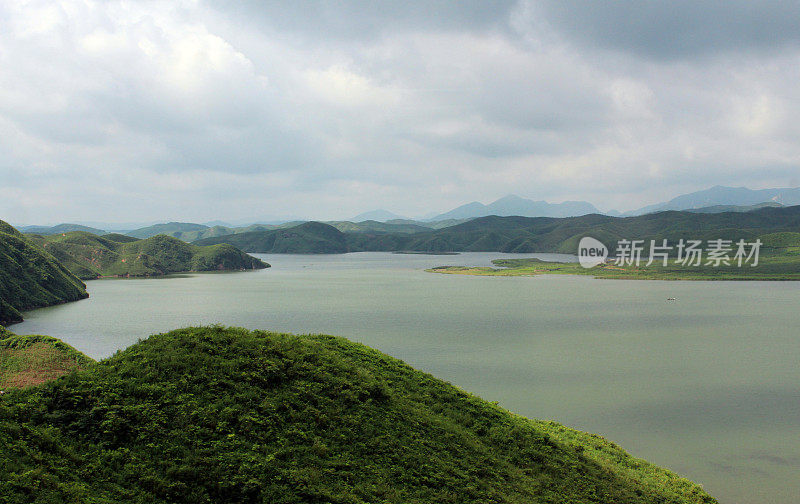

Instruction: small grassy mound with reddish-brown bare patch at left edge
[0,330,93,390]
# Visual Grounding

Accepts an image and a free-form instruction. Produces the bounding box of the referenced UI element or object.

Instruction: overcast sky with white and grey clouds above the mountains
[0,0,800,224]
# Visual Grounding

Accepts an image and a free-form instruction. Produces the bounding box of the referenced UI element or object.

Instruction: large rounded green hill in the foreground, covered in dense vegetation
[0,327,716,504]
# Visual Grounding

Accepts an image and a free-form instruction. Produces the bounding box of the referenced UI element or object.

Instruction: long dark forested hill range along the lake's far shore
[195,206,800,254]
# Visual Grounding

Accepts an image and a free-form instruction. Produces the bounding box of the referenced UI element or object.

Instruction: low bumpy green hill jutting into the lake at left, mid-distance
[29,232,269,279]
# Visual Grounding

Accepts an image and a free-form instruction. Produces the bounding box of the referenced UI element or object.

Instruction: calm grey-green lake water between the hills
[12,253,800,504]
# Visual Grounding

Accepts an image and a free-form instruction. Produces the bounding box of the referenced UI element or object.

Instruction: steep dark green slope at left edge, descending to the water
[0,221,89,324]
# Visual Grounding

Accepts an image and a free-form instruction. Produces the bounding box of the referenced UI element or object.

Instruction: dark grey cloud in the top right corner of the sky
[533,0,800,59]
